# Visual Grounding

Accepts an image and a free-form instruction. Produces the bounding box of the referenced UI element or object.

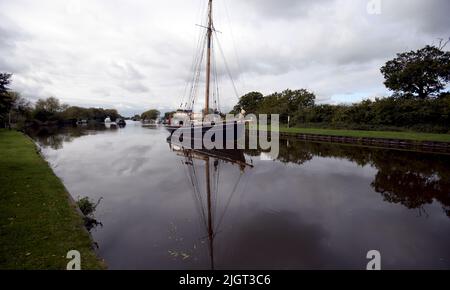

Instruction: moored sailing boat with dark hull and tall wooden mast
[166,0,249,141]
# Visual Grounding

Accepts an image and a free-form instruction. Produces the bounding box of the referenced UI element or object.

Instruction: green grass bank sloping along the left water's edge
[0,130,105,269]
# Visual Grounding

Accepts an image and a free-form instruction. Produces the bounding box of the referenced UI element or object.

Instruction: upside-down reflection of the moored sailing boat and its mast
[168,140,253,270]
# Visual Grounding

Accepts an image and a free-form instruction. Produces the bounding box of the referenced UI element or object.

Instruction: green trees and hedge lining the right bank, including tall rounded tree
[231,46,450,133]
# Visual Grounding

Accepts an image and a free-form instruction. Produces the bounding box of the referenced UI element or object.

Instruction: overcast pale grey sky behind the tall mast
[0,0,450,115]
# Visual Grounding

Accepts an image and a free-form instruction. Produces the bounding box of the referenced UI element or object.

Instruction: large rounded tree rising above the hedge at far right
[381,45,450,99]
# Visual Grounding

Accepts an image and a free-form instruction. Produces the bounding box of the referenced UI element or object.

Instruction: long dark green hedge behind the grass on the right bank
[293,94,450,133]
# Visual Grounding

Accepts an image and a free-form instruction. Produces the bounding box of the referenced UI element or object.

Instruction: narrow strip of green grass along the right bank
[251,127,450,142]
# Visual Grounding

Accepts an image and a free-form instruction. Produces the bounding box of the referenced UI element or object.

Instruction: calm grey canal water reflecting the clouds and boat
[27,123,450,269]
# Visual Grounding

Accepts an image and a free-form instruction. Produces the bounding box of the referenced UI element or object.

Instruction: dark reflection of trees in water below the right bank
[264,140,450,217]
